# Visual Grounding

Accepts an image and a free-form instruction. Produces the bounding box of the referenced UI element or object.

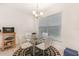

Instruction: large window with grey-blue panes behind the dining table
[39,13,61,38]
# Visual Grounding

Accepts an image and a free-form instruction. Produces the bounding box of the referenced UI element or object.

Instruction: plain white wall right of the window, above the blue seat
[48,4,79,51]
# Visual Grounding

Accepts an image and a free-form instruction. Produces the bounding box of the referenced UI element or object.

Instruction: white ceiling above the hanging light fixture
[0,3,61,15]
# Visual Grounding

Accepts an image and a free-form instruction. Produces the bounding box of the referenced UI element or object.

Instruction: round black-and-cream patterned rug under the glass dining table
[13,46,60,56]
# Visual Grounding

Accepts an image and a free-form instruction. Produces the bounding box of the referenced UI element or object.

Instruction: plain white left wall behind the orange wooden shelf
[0,5,34,47]
